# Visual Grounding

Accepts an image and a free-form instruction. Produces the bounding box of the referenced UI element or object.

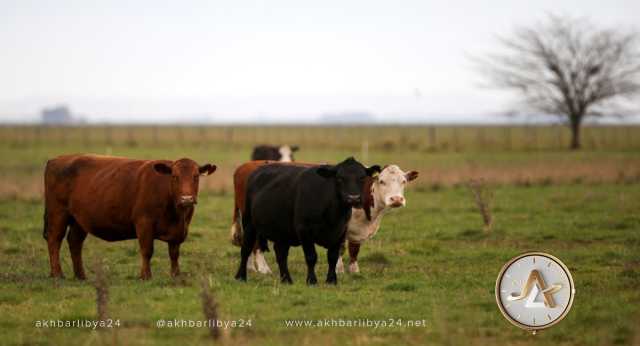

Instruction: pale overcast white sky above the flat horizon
[0,0,640,122]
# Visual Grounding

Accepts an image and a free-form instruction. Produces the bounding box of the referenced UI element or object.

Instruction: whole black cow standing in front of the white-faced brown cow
[236,157,380,285]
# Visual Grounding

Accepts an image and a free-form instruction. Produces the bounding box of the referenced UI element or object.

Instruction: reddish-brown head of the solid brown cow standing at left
[153,159,216,208]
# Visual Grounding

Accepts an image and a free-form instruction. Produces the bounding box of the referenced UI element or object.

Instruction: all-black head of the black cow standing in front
[317,157,380,208]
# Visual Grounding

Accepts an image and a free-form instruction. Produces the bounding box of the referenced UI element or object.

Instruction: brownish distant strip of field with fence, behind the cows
[0,126,640,199]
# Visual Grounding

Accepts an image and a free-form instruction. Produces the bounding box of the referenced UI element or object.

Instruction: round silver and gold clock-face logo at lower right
[496,252,575,331]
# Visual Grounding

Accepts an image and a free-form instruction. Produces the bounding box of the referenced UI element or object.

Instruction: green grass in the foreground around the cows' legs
[0,184,640,345]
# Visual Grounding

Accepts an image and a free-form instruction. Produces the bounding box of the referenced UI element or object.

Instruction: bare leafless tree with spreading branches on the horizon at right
[477,15,640,149]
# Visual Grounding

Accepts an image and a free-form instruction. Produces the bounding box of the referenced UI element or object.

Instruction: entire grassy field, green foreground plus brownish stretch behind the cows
[0,125,640,345]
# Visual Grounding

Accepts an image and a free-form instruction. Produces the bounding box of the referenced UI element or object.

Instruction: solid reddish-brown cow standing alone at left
[43,155,216,280]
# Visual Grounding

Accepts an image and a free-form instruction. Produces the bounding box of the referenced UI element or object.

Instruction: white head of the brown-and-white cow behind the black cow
[373,165,418,208]
